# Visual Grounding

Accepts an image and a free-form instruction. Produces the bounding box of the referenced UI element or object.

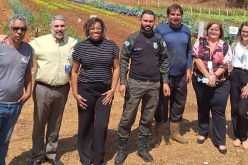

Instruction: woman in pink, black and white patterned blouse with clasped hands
[192,22,232,154]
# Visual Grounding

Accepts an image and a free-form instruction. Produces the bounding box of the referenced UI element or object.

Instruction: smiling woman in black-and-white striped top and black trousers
[71,18,120,165]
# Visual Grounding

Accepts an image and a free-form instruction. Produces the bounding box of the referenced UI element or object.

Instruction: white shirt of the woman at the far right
[232,42,248,70]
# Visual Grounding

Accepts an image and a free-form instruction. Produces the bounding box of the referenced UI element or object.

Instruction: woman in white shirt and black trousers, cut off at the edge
[230,22,248,149]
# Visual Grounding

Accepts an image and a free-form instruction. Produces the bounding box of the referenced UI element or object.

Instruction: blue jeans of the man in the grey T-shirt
[0,103,22,165]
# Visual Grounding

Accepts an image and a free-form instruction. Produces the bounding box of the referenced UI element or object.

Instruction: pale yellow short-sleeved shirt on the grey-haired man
[30,34,77,86]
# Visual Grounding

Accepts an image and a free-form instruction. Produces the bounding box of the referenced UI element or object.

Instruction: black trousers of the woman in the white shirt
[230,68,248,141]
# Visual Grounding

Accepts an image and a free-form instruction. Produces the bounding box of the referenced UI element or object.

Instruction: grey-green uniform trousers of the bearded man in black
[118,78,160,139]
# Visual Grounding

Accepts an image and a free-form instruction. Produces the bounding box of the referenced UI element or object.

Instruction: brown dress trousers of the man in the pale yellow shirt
[32,83,70,161]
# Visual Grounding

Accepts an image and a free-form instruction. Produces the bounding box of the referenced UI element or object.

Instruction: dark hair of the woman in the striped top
[84,17,106,38]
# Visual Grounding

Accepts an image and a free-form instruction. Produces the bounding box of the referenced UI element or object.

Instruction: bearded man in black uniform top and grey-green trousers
[115,10,170,164]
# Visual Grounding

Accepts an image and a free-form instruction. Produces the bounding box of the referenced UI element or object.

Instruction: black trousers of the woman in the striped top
[78,83,111,165]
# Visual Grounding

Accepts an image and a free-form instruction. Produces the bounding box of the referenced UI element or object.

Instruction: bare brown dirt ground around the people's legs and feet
[7,86,248,165]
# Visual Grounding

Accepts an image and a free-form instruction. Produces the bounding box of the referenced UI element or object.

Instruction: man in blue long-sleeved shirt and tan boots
[151,4,192,147]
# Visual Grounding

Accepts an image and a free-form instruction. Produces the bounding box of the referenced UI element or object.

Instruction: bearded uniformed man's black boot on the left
[115,138,127,165]
